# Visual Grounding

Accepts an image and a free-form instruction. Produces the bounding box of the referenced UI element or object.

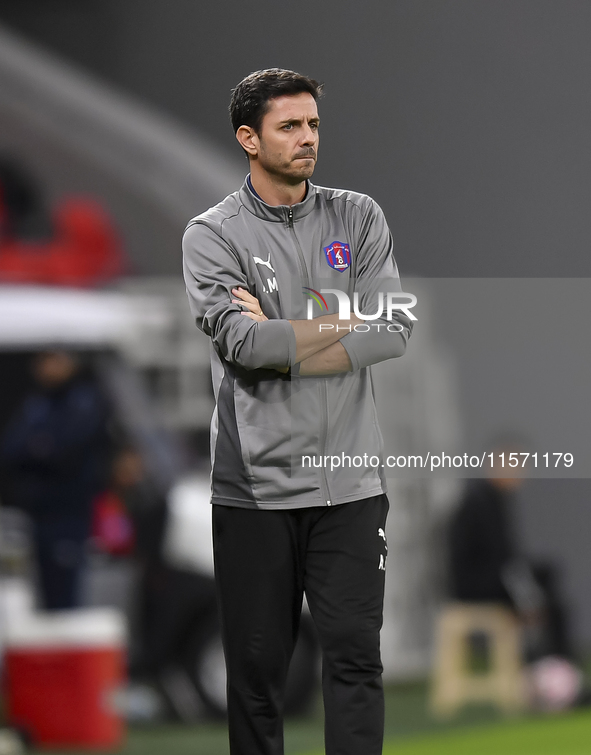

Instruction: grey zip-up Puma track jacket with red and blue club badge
[183,182,412,509]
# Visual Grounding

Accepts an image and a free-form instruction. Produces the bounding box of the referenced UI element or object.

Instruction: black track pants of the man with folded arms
[213,495,388,755]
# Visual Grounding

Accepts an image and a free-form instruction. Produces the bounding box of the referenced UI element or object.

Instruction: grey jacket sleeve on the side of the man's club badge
[341,200,413,370]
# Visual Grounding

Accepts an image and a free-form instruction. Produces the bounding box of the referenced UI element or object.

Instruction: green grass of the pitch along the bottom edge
[27,663,591,755]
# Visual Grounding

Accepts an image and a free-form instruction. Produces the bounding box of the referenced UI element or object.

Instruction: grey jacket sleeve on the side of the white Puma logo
[183,222,296,370]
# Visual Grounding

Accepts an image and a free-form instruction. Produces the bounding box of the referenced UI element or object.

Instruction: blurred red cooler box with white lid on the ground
[4,609,125,749]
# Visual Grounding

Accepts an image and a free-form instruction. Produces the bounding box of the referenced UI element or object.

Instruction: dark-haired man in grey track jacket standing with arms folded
[183,69,411,755]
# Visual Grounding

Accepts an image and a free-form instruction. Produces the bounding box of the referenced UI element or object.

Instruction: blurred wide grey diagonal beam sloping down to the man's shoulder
[0,27,243,272]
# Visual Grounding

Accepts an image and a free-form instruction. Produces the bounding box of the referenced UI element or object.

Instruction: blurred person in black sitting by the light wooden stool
[448,439,572,661]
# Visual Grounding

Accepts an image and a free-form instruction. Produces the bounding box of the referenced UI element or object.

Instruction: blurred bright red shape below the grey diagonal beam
[0,198,126,287]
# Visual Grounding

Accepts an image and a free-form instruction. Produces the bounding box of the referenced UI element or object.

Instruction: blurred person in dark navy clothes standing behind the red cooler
[0,350,108,610]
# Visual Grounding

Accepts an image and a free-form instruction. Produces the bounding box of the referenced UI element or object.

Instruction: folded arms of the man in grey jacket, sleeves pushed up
[183,202,412,375]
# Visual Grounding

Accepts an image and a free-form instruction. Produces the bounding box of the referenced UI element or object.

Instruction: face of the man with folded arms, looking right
[253,92,320,185]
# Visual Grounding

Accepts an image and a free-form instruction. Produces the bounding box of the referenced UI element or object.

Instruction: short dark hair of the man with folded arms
[230,68,323,134]
